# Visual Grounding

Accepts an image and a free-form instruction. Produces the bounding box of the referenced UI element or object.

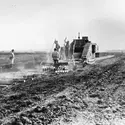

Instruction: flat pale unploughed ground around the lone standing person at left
[0,52,47,85]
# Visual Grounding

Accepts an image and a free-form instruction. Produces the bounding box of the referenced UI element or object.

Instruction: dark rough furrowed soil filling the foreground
[0,55,125,125]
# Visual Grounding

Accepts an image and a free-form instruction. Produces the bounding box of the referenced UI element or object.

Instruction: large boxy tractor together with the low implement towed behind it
[41,33,99,72]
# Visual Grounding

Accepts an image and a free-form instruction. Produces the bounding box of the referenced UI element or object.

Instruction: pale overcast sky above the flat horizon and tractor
[0,0,125,51]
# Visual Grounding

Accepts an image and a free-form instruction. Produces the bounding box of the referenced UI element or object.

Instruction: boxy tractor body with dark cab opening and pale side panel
[70,36,98,61]
